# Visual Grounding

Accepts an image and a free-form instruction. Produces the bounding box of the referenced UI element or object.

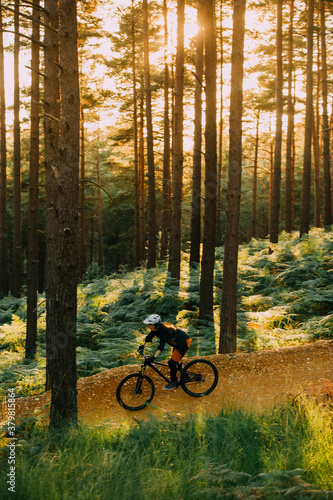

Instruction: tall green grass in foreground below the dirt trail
[0,401,333,500]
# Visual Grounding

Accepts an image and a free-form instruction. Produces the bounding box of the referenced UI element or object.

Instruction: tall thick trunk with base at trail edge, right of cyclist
[219,0,246,353]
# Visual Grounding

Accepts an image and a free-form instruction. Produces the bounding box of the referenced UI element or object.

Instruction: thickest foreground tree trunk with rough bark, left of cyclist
[47,0,80,428]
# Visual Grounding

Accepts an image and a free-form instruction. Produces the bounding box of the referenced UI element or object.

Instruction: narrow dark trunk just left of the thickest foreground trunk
[25,0,40,359]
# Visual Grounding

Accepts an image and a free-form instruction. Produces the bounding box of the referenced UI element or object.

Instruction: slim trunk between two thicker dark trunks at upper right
[284,0,295,233]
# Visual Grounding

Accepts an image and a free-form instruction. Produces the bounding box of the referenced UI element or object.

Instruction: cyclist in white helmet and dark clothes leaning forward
[139,314,192,389]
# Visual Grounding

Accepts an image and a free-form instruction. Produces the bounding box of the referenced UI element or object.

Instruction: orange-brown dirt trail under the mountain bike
[0,340,333,425]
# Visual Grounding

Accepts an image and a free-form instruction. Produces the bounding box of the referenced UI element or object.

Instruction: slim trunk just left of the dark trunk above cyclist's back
[160,0,171,260]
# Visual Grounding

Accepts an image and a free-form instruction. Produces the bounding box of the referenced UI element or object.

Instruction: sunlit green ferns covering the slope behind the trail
[0,229,333,396]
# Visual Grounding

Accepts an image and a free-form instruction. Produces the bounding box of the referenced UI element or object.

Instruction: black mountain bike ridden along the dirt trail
[116,354,219,411]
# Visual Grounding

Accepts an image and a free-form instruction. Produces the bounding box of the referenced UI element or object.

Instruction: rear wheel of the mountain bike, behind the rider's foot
[180,359,219,397]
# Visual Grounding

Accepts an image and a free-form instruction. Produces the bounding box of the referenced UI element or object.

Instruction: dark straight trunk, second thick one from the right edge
[300,0,314,236]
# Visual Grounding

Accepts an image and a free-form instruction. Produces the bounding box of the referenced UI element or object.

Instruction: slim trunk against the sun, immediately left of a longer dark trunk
[190,1,204,264]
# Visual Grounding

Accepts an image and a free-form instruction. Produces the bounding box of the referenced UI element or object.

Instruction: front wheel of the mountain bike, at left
[116,373,155,411]
